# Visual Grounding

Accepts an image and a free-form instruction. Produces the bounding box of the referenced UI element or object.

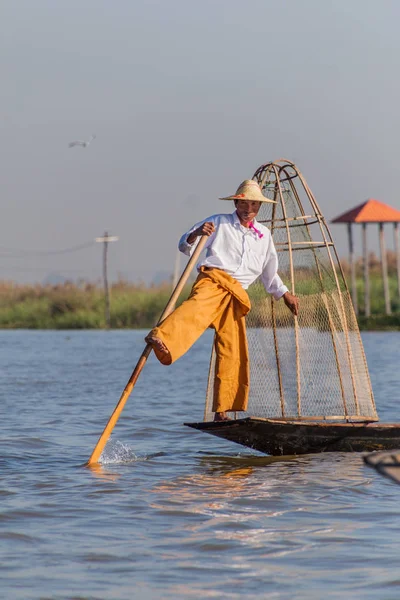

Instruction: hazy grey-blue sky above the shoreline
[0,0,400,281]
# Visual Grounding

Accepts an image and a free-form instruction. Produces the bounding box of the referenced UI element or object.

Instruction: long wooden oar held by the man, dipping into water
[86,235,208,466]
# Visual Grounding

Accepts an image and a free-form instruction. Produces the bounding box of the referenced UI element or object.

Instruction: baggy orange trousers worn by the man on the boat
[151,267,251,412]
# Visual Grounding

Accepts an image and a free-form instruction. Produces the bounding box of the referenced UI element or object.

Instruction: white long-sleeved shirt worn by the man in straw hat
[179,211,288,300]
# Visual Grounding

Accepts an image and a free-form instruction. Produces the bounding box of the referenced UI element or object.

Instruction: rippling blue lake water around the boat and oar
[0,331,400,600]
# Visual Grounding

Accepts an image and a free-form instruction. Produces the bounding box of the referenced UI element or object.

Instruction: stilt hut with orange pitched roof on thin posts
[332,198,400,317]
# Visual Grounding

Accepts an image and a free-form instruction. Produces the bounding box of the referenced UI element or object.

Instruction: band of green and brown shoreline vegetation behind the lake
[0,269,400,331]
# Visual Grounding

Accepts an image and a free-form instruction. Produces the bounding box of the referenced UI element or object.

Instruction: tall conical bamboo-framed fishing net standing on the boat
[204,159,378,422]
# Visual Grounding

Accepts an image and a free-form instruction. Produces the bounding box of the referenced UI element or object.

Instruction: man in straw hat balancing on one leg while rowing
[145,179,299,421]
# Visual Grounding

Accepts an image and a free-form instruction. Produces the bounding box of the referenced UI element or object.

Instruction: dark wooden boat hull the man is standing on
[185,417,400,456]
